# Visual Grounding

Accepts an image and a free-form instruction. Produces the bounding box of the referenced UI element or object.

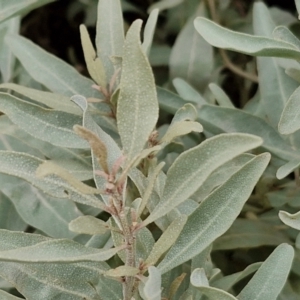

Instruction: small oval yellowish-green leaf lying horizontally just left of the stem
[69,216,108,235]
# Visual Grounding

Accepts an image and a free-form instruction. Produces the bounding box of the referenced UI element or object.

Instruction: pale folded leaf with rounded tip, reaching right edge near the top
[194,17,300,60]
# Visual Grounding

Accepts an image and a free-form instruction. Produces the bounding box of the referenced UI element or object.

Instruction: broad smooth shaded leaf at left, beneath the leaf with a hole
[0,174,81,238]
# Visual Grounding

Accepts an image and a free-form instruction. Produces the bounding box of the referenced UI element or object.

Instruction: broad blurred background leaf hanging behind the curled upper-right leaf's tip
[169,2,214,90]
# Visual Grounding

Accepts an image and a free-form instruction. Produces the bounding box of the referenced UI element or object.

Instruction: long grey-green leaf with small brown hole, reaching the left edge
[0,151,105,209]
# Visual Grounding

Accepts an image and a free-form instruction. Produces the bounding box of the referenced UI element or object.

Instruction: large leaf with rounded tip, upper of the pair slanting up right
[144,134,262,224]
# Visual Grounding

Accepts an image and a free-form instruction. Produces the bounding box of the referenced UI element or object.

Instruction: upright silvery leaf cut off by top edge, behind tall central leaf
[96,0,124,79]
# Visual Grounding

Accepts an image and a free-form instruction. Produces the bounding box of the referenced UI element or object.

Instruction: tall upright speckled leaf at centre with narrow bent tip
[117,20,158,162]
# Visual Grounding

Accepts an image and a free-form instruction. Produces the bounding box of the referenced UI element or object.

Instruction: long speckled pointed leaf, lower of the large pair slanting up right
[158,154,270,273]
